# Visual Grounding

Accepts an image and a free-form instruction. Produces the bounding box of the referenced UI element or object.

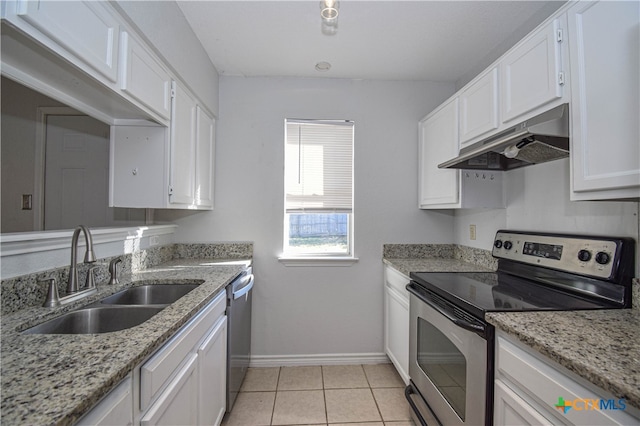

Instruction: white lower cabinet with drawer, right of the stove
[494,332,640,425]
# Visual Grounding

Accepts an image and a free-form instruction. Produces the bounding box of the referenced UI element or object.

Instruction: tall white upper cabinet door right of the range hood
[568,1,640,200]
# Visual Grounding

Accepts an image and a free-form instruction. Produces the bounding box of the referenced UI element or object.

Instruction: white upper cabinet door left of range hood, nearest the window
[418,98,460,209]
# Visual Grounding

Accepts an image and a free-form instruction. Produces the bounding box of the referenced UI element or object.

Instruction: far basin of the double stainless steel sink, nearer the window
[100,284,199,305]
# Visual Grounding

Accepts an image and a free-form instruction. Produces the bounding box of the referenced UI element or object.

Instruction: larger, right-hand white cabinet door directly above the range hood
[500,15,566,124]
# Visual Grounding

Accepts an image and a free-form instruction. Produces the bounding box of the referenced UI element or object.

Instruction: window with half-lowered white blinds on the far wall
[284,119,354,257]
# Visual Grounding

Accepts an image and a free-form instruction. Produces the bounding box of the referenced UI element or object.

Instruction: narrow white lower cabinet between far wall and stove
[384,266,409,384]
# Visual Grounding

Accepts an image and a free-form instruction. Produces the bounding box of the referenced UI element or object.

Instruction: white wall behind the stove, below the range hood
[455,159,640,272]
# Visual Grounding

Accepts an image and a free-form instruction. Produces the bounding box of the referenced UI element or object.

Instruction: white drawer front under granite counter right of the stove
[497,337,638,425]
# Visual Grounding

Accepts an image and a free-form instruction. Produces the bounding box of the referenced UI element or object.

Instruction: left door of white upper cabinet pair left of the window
[169,81,196,205]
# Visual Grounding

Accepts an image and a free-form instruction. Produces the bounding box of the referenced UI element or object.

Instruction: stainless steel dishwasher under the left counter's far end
[227,267,254,413]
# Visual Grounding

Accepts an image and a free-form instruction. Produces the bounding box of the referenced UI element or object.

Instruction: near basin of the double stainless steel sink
[23,306,164,334]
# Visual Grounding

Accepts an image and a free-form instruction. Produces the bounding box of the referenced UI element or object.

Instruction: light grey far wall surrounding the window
[162,76,454,360]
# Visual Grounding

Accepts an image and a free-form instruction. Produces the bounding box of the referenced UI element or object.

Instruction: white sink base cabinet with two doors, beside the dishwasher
[139,291,227,425]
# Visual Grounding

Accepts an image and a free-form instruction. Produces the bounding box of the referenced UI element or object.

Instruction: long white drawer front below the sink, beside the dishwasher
[140,290,227,410]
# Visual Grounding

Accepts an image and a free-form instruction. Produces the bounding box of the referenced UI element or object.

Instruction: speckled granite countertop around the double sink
[0,259,250,425]
